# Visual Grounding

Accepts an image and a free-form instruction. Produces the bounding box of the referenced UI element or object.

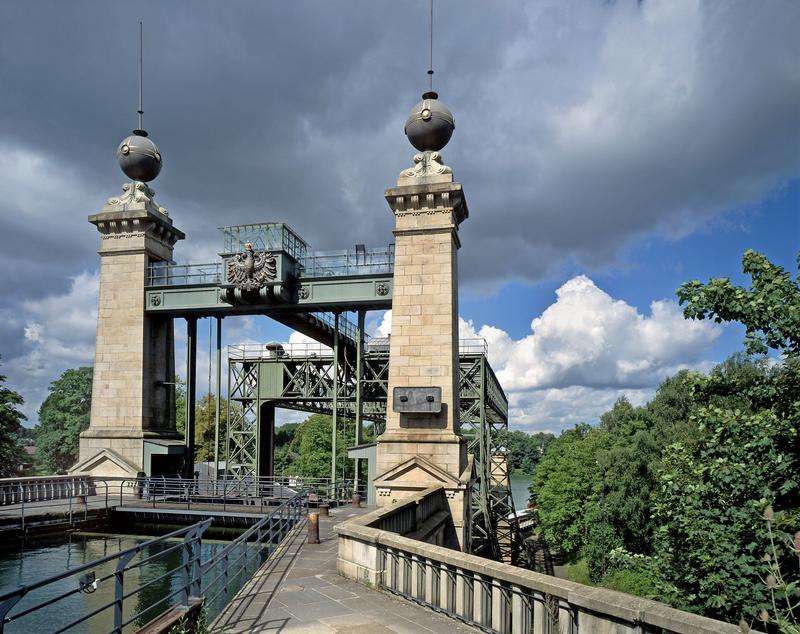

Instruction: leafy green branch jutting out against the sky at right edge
[678,250,800,357]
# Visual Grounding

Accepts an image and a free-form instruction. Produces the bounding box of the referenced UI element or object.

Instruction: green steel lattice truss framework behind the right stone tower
[227,342,521,562]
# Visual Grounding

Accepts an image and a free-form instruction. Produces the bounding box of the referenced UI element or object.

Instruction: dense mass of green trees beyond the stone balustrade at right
[533,355,800,622]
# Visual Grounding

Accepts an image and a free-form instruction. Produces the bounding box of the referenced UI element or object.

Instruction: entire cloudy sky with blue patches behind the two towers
[0,0,800,431]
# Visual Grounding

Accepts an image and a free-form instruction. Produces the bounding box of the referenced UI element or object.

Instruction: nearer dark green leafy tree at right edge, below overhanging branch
[654,358,800,621]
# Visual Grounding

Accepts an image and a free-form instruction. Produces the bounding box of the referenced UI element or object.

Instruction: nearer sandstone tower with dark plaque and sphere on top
[375,92,473,550]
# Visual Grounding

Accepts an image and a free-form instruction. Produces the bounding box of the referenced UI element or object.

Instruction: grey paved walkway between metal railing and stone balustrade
[211,508,478,634]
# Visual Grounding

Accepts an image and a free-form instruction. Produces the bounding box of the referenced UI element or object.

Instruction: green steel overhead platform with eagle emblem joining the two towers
[145,223,394,346]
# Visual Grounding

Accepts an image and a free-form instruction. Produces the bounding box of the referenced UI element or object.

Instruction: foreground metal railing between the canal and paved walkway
[0,493,306,634]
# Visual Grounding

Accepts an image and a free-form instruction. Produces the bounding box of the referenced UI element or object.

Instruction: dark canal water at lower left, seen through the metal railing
[0,533,260,634]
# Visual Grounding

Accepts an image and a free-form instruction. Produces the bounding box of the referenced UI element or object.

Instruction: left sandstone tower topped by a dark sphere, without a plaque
[71,130,184,476]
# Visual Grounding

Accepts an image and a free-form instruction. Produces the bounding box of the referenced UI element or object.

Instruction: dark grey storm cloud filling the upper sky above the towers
[0,0,800,424]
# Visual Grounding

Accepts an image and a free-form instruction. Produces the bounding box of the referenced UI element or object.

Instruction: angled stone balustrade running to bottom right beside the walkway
[334,487,752,634]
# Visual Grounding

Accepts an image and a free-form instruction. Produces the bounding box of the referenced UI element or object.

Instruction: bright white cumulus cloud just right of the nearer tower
[380,275,722,431]
